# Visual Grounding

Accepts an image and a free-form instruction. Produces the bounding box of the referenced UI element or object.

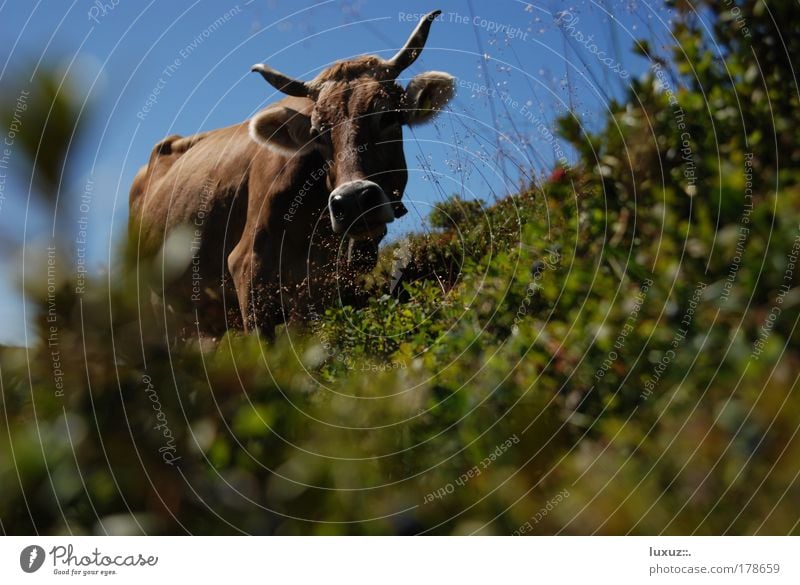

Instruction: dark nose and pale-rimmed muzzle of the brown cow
[328,180,395,239]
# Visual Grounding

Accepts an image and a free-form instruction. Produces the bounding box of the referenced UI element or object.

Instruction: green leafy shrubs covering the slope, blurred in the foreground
[0,2,800,534]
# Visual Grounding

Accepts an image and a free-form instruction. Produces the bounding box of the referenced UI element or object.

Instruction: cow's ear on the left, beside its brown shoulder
[250,106,315,156]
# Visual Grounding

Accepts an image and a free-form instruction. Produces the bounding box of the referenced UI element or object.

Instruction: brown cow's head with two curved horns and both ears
[250,10,454,258]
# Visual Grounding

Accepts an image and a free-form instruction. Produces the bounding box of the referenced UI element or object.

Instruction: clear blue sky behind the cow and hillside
[0,0,669,344]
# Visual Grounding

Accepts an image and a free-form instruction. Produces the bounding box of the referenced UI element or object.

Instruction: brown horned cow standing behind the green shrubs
[129,10,455,336]
